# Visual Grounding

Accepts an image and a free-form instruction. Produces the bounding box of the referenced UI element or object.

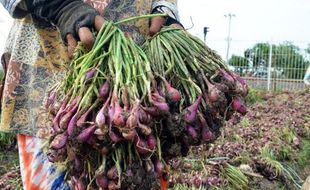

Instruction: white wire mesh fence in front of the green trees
[217,42,310,91]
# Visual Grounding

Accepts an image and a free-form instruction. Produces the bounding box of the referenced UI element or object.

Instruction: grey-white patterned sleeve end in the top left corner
[0,0,28,18]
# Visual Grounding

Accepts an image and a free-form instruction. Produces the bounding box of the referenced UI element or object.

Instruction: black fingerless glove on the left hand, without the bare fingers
[26,0,99,42]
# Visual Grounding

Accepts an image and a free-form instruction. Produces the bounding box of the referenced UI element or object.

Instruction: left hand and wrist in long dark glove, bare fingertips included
[26,0,104,57]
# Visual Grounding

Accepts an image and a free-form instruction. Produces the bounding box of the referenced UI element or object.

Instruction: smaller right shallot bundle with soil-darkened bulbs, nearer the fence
[144,27,248,154]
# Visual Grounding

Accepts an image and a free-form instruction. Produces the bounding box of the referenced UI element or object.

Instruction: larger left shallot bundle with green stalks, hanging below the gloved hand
[46,15,169,190]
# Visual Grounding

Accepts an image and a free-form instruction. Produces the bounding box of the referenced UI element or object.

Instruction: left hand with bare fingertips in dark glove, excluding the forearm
[49,0,104,58]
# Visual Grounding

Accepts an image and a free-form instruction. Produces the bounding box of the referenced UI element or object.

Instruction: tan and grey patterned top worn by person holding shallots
[0,0,178,138]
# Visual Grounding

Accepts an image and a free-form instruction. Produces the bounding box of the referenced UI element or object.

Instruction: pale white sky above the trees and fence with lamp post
[0,0,310,58]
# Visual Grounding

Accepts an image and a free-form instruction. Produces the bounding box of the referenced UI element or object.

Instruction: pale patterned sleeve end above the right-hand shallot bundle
[152,0,180,21]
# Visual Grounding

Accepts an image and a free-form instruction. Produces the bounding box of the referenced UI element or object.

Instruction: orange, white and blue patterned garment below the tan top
[17,134,71,190]
